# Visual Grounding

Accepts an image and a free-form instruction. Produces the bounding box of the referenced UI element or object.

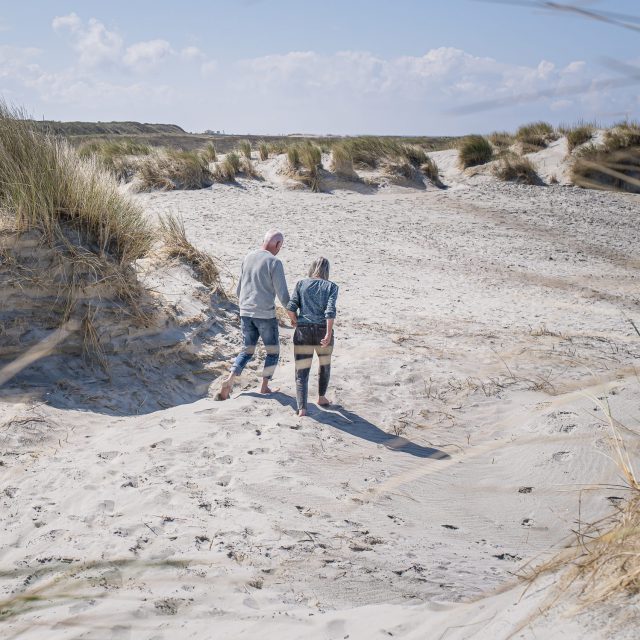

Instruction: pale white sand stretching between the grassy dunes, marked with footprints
[0,152,640,640]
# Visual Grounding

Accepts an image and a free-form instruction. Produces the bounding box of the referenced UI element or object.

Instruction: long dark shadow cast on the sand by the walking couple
[238,392,451,460]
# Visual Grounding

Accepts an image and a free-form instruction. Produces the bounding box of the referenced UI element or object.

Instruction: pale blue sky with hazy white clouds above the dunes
[0,0,640,135]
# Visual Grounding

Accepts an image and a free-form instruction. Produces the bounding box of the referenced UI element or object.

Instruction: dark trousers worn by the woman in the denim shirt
[293,324,333,410]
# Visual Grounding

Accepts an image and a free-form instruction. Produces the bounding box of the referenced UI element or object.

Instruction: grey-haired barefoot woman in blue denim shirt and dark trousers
[287,258,338,416]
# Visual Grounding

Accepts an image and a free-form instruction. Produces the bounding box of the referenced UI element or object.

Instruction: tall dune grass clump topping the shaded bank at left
[0,103,153,264]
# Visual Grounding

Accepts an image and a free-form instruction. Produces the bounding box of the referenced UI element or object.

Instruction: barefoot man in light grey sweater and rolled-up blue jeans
[220,229,289,400]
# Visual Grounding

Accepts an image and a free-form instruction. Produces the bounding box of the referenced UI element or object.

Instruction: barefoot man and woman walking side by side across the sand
[220,229,338,416]
